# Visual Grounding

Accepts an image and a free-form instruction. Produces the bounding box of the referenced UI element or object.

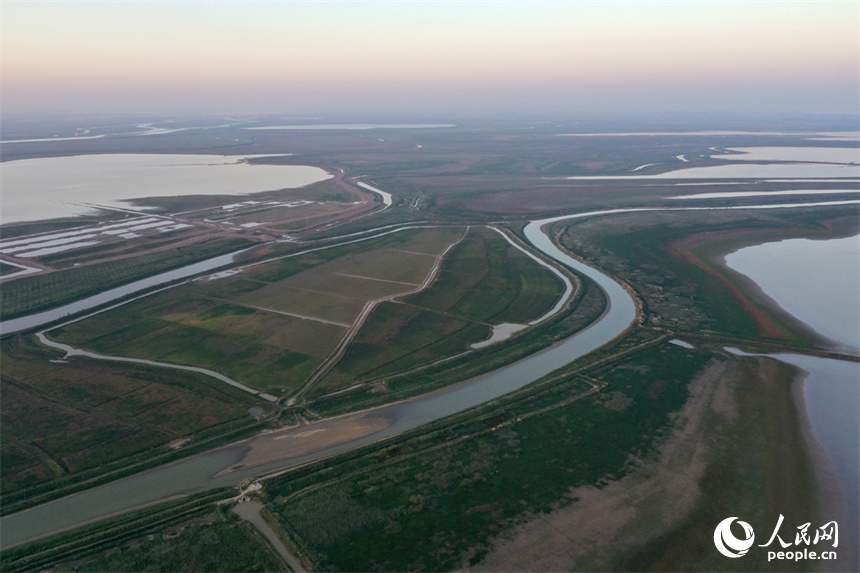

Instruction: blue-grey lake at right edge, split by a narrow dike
[726,236,860,560]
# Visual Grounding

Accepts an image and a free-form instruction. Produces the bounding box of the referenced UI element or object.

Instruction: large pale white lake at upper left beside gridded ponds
[0,154,332,224]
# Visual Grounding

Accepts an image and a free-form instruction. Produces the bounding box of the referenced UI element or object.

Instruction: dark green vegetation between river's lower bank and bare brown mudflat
[265,336,711,571]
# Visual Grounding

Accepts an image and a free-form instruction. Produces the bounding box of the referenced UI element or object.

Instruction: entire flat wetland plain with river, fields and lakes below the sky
[0,120,860,571]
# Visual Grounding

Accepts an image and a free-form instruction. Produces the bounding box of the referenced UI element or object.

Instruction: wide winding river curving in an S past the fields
[0,201,858,548]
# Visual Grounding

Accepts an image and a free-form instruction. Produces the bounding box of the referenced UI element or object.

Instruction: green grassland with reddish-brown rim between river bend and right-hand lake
[562,208,857,347]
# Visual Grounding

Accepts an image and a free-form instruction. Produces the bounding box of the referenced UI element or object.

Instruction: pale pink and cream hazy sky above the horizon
[0,0,860,116]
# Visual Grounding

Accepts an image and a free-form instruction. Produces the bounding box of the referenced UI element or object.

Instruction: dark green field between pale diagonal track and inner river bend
[319,227,564,392]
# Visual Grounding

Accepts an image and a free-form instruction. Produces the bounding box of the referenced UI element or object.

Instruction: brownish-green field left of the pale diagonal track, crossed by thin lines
[52,228,470,396]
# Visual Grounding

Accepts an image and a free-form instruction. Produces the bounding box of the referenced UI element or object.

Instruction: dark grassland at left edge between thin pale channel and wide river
[0,336,266,504]
